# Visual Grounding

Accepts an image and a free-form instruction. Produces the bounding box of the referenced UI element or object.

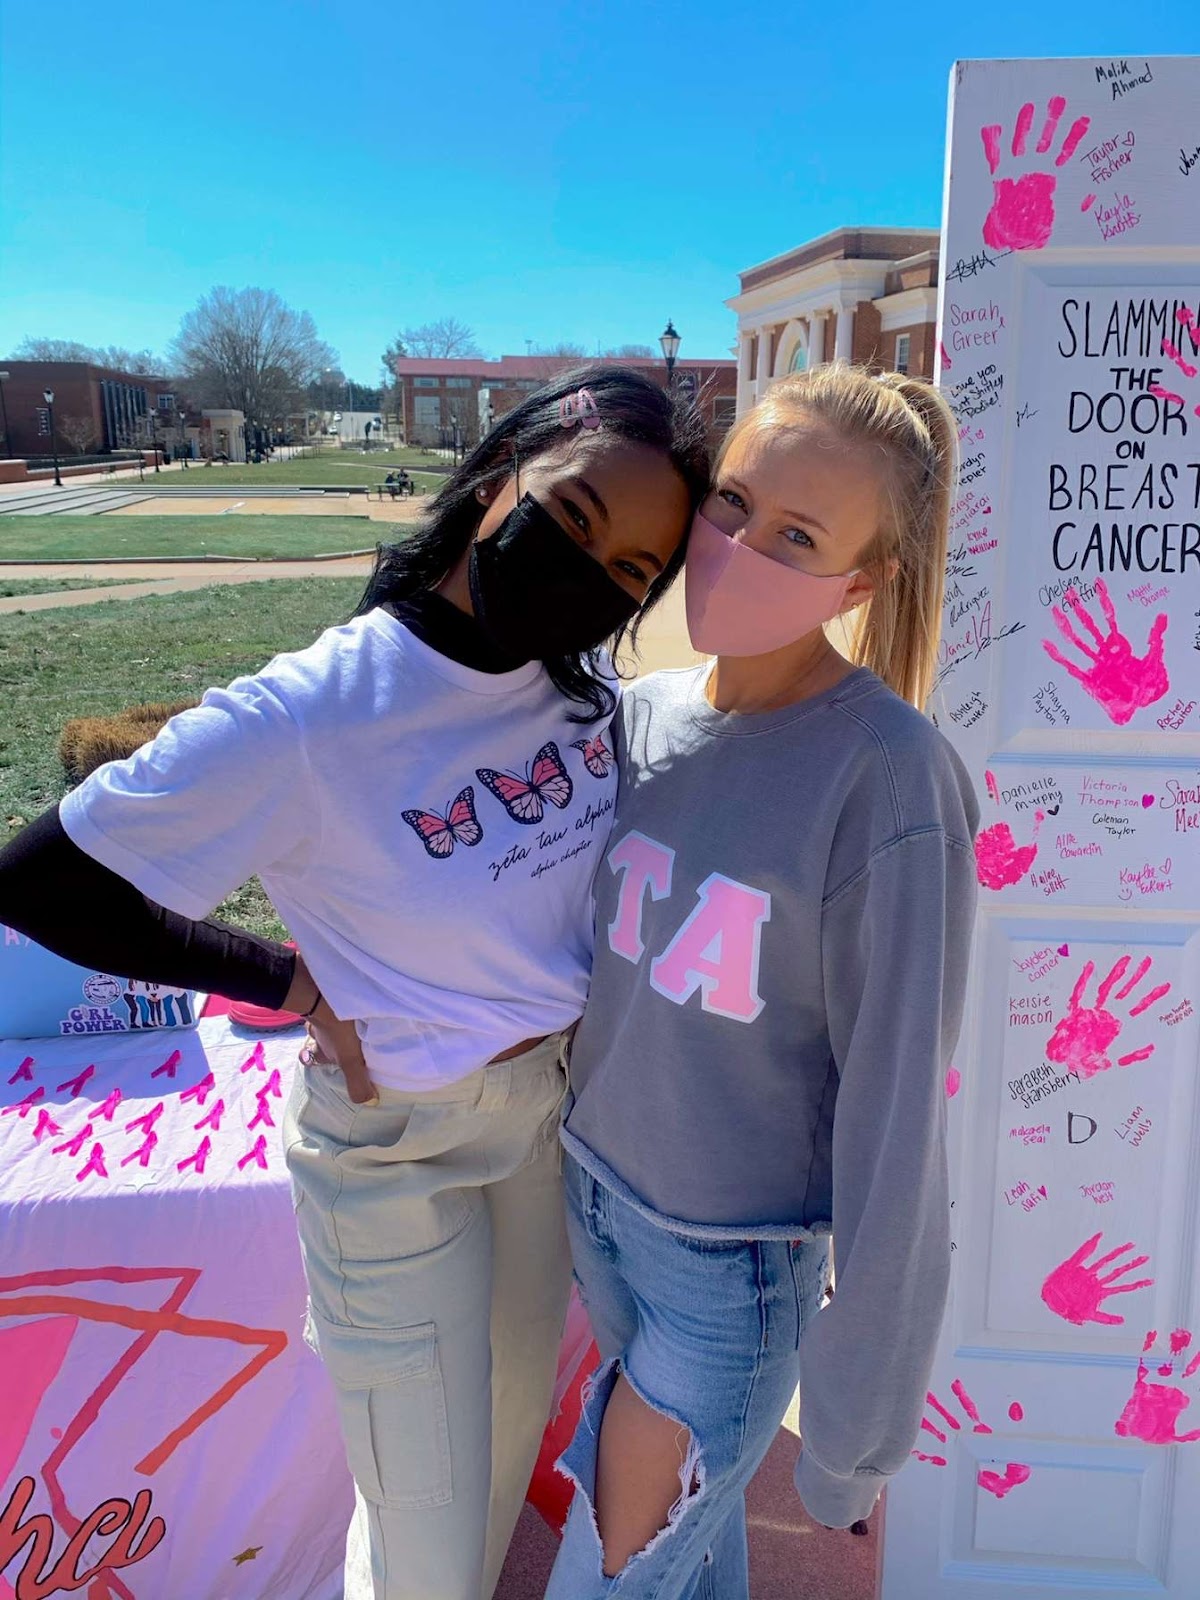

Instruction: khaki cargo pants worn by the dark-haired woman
[283,1035,571,1600]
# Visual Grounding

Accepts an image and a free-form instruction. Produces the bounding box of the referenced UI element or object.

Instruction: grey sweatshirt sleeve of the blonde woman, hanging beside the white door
[795,827,978,1528]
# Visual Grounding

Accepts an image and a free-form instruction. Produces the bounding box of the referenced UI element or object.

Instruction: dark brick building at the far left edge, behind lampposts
[0,362,179,456]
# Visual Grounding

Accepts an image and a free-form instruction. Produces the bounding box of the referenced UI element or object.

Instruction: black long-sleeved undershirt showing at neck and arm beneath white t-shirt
[0,594,520,1010]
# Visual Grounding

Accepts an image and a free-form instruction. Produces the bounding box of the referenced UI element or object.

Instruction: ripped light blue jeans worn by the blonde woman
[546,1155,829,1600]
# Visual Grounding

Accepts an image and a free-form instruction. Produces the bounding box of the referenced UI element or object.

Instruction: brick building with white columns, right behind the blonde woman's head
[726,227,941,416]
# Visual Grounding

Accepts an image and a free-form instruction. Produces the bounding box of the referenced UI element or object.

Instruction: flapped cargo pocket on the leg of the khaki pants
[304,1307,453,1510]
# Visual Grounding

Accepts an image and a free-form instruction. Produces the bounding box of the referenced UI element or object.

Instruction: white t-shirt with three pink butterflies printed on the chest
[61,610,616,1090]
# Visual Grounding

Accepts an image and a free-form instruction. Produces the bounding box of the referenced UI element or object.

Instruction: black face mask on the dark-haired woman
[467,494,638,661]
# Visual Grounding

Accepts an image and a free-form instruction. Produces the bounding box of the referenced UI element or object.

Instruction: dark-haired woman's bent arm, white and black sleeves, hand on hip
[10,672,374,1101]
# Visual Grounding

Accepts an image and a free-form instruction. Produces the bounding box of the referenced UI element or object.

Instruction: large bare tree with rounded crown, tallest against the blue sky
[171,286,338,427]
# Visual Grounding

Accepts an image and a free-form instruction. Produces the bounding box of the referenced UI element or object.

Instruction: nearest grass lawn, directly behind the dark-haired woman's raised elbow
[0,582,362,938]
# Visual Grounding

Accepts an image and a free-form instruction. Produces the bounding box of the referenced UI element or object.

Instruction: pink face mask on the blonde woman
[683,512,858,656]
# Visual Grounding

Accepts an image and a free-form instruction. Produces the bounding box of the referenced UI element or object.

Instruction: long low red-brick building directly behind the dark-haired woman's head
[394,355,736,445]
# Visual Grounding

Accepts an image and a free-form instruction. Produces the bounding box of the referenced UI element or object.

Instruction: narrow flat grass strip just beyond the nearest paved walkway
[0,514,385,563]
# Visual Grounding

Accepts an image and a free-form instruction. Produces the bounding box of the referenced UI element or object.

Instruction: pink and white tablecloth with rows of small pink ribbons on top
[0,1016,350,1600]
